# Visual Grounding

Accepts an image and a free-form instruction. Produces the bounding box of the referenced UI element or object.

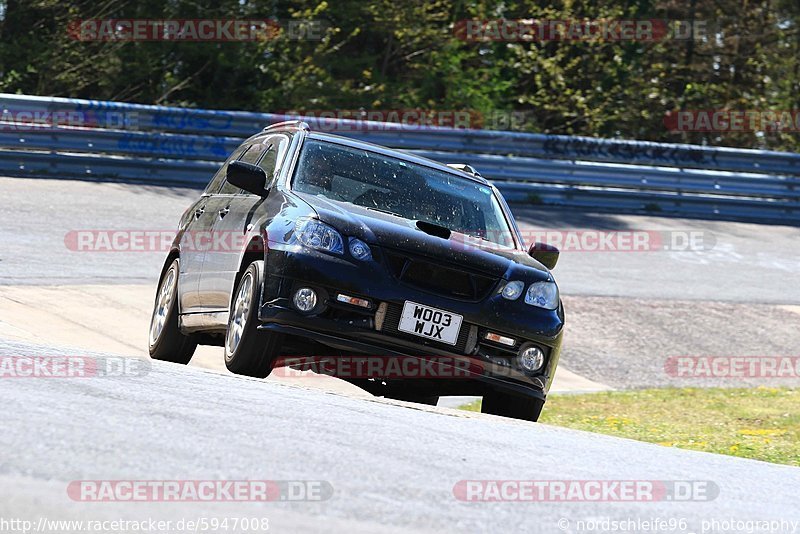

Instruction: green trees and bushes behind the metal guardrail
[0,0,800,151]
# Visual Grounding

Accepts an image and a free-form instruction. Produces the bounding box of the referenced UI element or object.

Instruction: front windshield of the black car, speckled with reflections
[292,139,514,252]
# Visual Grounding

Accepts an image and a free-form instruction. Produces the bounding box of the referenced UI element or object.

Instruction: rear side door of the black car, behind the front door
[178,146,244,313]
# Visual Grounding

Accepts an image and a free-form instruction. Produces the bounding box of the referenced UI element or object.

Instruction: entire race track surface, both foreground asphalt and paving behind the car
[0,178,800,533]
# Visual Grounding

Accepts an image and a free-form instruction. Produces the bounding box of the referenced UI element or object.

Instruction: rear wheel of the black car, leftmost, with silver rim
[148,258,197,365]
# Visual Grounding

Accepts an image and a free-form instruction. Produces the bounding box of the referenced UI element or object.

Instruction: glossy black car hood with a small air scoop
[292,191,550,281]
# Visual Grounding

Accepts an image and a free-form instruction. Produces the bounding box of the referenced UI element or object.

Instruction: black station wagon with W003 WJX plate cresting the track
[149,121,564,421]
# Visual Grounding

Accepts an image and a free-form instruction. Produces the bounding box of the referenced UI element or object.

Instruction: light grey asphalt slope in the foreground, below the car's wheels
[0,344,800,533]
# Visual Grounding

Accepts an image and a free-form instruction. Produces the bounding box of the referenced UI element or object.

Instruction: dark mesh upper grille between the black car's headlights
[386,251,498,302]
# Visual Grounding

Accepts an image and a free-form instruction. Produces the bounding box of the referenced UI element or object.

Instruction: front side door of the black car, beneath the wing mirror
[199,134,289,311]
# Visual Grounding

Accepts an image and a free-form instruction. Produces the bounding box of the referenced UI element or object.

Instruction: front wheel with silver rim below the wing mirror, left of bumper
[225,260,282,378]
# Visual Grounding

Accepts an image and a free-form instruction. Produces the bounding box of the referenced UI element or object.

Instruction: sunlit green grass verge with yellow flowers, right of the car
[461,387,800,466]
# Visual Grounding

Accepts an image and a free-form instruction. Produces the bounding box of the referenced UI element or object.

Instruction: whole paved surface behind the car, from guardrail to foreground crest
[0,178,800,391]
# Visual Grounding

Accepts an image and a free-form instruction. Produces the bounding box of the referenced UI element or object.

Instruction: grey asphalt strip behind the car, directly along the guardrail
[0,178,800,304]
